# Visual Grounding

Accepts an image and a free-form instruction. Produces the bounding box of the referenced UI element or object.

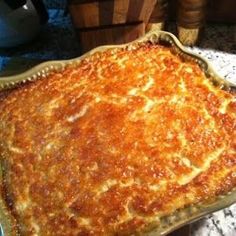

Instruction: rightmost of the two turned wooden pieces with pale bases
[177,0,207,45]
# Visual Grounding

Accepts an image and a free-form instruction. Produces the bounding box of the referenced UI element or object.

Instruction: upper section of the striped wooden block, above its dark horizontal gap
[69,0,156,28]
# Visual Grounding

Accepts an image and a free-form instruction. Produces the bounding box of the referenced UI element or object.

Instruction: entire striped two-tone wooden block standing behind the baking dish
[68,0,157,52]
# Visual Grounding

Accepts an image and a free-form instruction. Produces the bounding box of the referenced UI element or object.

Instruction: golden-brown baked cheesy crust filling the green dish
[0,44,236,235]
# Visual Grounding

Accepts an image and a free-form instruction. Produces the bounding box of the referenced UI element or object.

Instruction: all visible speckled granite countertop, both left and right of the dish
[0,10,236,236]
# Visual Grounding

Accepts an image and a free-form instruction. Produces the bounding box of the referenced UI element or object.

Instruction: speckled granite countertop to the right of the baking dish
[180,25,236,236]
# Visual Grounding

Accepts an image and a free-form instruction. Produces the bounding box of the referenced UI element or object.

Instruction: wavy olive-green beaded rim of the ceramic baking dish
[0,30,236,236]
